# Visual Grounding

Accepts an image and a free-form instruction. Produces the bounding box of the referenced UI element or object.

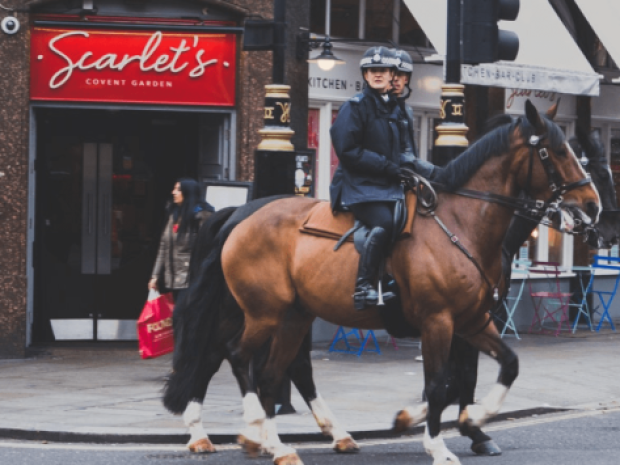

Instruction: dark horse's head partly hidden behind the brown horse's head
[569,128,620,249]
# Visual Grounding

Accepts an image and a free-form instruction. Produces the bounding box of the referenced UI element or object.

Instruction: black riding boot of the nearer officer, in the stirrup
[353,226,388,310]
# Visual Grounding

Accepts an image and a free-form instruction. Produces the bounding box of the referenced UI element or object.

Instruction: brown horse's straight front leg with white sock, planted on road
[422,320,461,465]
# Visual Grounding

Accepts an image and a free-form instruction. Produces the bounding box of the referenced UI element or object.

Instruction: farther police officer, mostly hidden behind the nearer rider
[392,50,440,180]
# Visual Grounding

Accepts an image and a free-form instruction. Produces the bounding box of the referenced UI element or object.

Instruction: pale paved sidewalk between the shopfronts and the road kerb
[0,330,620,443]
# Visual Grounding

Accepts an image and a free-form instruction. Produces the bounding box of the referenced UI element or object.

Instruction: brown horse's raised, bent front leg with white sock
[459,322,519,427]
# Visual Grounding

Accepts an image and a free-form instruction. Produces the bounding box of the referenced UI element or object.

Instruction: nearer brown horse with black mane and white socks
[221,101,600,465]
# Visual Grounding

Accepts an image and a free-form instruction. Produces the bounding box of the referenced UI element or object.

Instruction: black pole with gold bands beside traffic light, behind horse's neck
[433,0,469,166]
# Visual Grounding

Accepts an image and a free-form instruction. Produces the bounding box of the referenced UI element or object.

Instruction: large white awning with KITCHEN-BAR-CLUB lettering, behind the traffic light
[404,0,600,96]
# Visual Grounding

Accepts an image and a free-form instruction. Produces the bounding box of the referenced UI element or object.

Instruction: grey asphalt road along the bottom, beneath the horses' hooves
[0,409,620,465]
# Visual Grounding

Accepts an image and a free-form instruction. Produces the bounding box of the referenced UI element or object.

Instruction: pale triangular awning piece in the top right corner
[575,0,620,79]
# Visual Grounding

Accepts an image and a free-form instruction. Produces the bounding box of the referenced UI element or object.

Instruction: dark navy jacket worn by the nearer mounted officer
[330,87,404,210]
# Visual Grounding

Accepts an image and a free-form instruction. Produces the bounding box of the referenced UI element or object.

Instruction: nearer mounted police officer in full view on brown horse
[330,47,411,310]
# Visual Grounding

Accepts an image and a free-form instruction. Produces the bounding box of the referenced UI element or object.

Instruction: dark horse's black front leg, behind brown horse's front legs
[450,336,502,456]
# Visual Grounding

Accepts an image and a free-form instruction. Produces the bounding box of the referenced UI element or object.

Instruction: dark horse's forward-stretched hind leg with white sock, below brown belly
[286,332,359,453]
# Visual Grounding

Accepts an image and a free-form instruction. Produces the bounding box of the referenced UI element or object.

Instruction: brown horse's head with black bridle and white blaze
[515,100,601,230]
